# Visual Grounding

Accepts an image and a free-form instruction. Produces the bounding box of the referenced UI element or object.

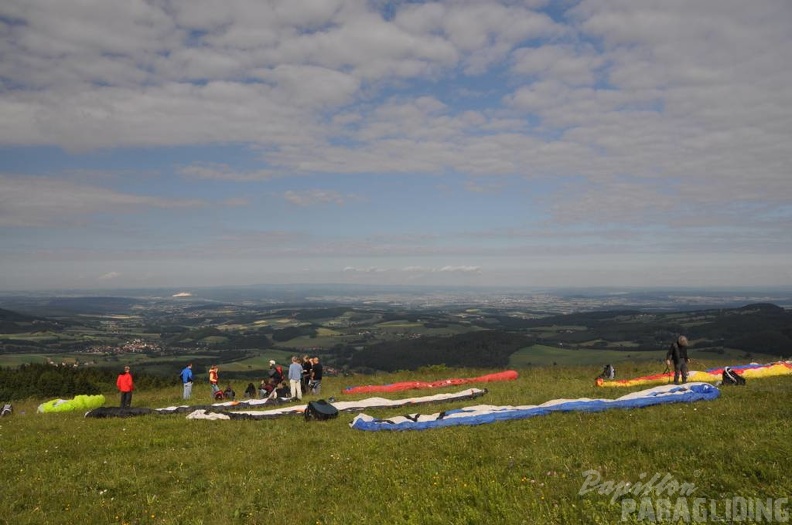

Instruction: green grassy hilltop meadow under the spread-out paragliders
[0,363,792,525]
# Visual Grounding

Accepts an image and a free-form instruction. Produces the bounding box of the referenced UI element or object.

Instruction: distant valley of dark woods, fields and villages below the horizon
[0,285,792,378]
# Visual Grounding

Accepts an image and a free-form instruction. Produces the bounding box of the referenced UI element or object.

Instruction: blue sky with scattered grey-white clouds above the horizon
[0,0,792,291]
